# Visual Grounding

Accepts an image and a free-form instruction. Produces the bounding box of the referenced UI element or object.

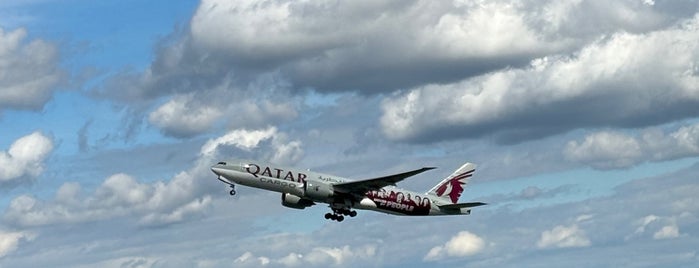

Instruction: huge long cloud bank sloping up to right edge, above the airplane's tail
[381,14,699,142]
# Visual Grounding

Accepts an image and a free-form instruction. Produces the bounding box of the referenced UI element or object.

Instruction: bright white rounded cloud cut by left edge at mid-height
[0,132,53,185]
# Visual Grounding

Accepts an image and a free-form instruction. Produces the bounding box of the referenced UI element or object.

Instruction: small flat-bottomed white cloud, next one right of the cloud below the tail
[536,224,590,248]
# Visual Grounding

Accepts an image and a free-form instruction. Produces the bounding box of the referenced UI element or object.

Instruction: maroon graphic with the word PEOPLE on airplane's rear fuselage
[366,189,431,215]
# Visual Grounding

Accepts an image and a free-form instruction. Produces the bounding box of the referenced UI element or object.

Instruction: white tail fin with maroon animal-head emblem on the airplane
[427,163,476,204]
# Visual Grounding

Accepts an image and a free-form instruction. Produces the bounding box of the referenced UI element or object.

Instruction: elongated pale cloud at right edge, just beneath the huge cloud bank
[563,124,699,169]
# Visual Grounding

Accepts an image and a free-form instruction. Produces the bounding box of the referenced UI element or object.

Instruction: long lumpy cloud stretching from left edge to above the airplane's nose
[3,127,303,227]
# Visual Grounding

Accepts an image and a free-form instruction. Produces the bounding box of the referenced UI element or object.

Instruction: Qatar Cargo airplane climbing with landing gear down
[211,159,486,222]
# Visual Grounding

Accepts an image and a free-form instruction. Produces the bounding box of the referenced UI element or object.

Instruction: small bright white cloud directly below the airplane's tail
[423,231,485,261]
